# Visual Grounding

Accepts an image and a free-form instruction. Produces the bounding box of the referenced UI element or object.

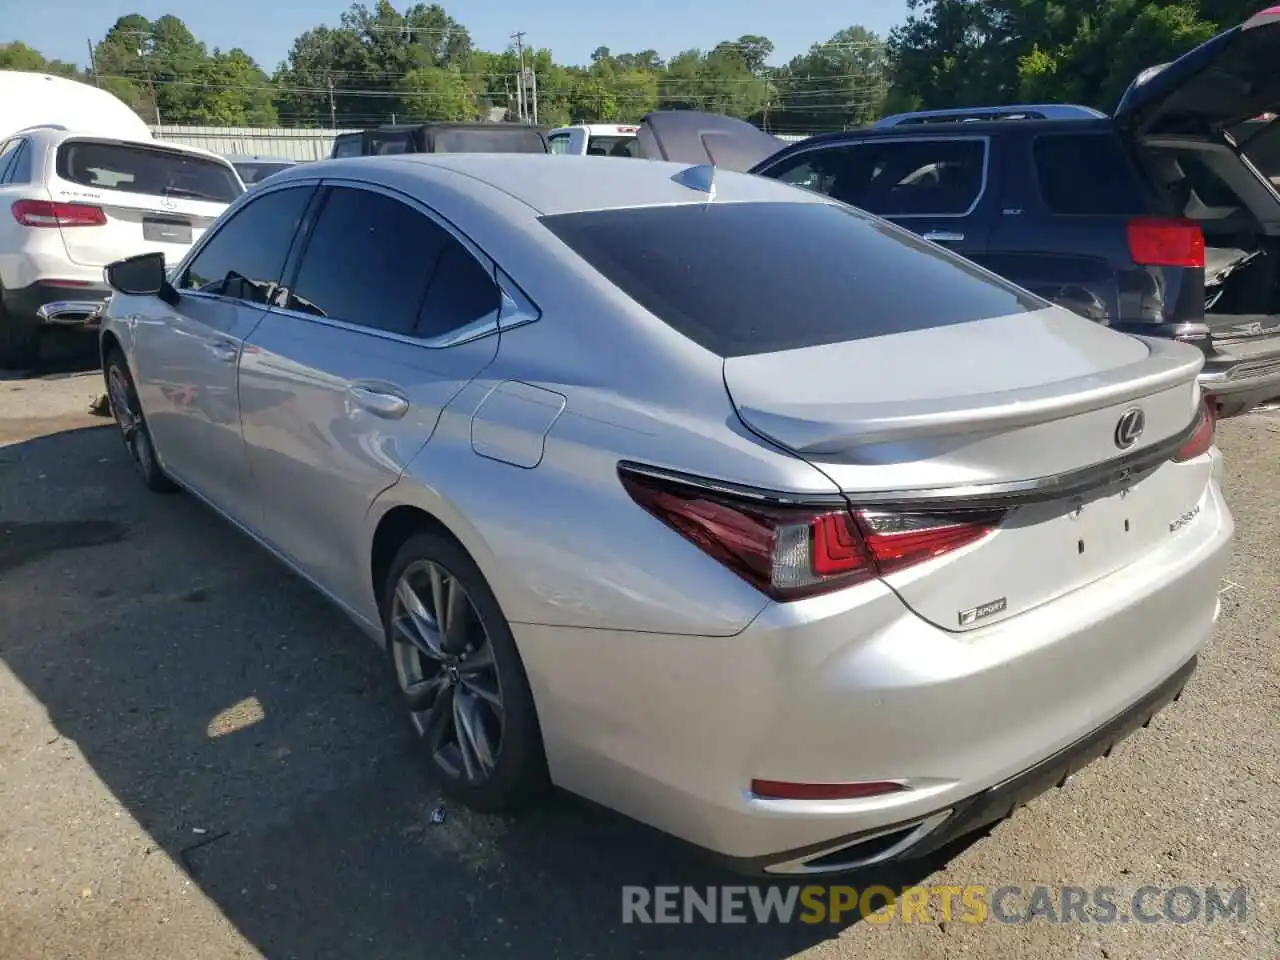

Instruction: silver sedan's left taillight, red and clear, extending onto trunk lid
[618,466,1004,600]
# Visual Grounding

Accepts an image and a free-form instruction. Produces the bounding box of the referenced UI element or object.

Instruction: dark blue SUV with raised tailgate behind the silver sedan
[641,8,1280,416]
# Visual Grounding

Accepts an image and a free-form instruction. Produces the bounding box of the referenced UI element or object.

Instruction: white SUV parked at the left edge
[0,125,244,369]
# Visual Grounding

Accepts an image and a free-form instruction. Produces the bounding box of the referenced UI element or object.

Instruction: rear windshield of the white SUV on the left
[58,140,244,204]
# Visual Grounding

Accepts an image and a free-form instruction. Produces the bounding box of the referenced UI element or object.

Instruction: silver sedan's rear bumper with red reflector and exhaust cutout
[513,478,1234,876]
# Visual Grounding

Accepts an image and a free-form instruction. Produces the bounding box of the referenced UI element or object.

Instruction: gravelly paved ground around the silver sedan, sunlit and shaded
[0,363,1280,960]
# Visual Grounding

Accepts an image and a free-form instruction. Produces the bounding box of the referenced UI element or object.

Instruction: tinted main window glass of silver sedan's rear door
[289,188,451,334]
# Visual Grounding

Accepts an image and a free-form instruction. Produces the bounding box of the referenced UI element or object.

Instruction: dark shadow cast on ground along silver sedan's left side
[0,428,983,960]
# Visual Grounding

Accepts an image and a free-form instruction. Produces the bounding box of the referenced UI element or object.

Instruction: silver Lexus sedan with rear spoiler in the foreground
[94,155,1233,874]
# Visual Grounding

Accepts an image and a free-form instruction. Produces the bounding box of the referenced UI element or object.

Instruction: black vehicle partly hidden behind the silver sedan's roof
[329,123,549,159]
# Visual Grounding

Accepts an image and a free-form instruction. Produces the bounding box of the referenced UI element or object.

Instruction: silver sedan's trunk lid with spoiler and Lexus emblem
[724,308,1208,630]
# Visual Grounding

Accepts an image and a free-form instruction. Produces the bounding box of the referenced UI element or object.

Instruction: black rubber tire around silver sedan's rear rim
[381,531,550,813]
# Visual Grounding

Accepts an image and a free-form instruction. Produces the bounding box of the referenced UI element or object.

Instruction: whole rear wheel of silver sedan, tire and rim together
[383,532,549,813]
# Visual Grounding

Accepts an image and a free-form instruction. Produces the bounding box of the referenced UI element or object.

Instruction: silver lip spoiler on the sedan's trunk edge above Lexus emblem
[740,337,1204,457]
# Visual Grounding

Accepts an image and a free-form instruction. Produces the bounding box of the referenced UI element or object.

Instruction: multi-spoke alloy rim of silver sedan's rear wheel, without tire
[390,561,506,785]
